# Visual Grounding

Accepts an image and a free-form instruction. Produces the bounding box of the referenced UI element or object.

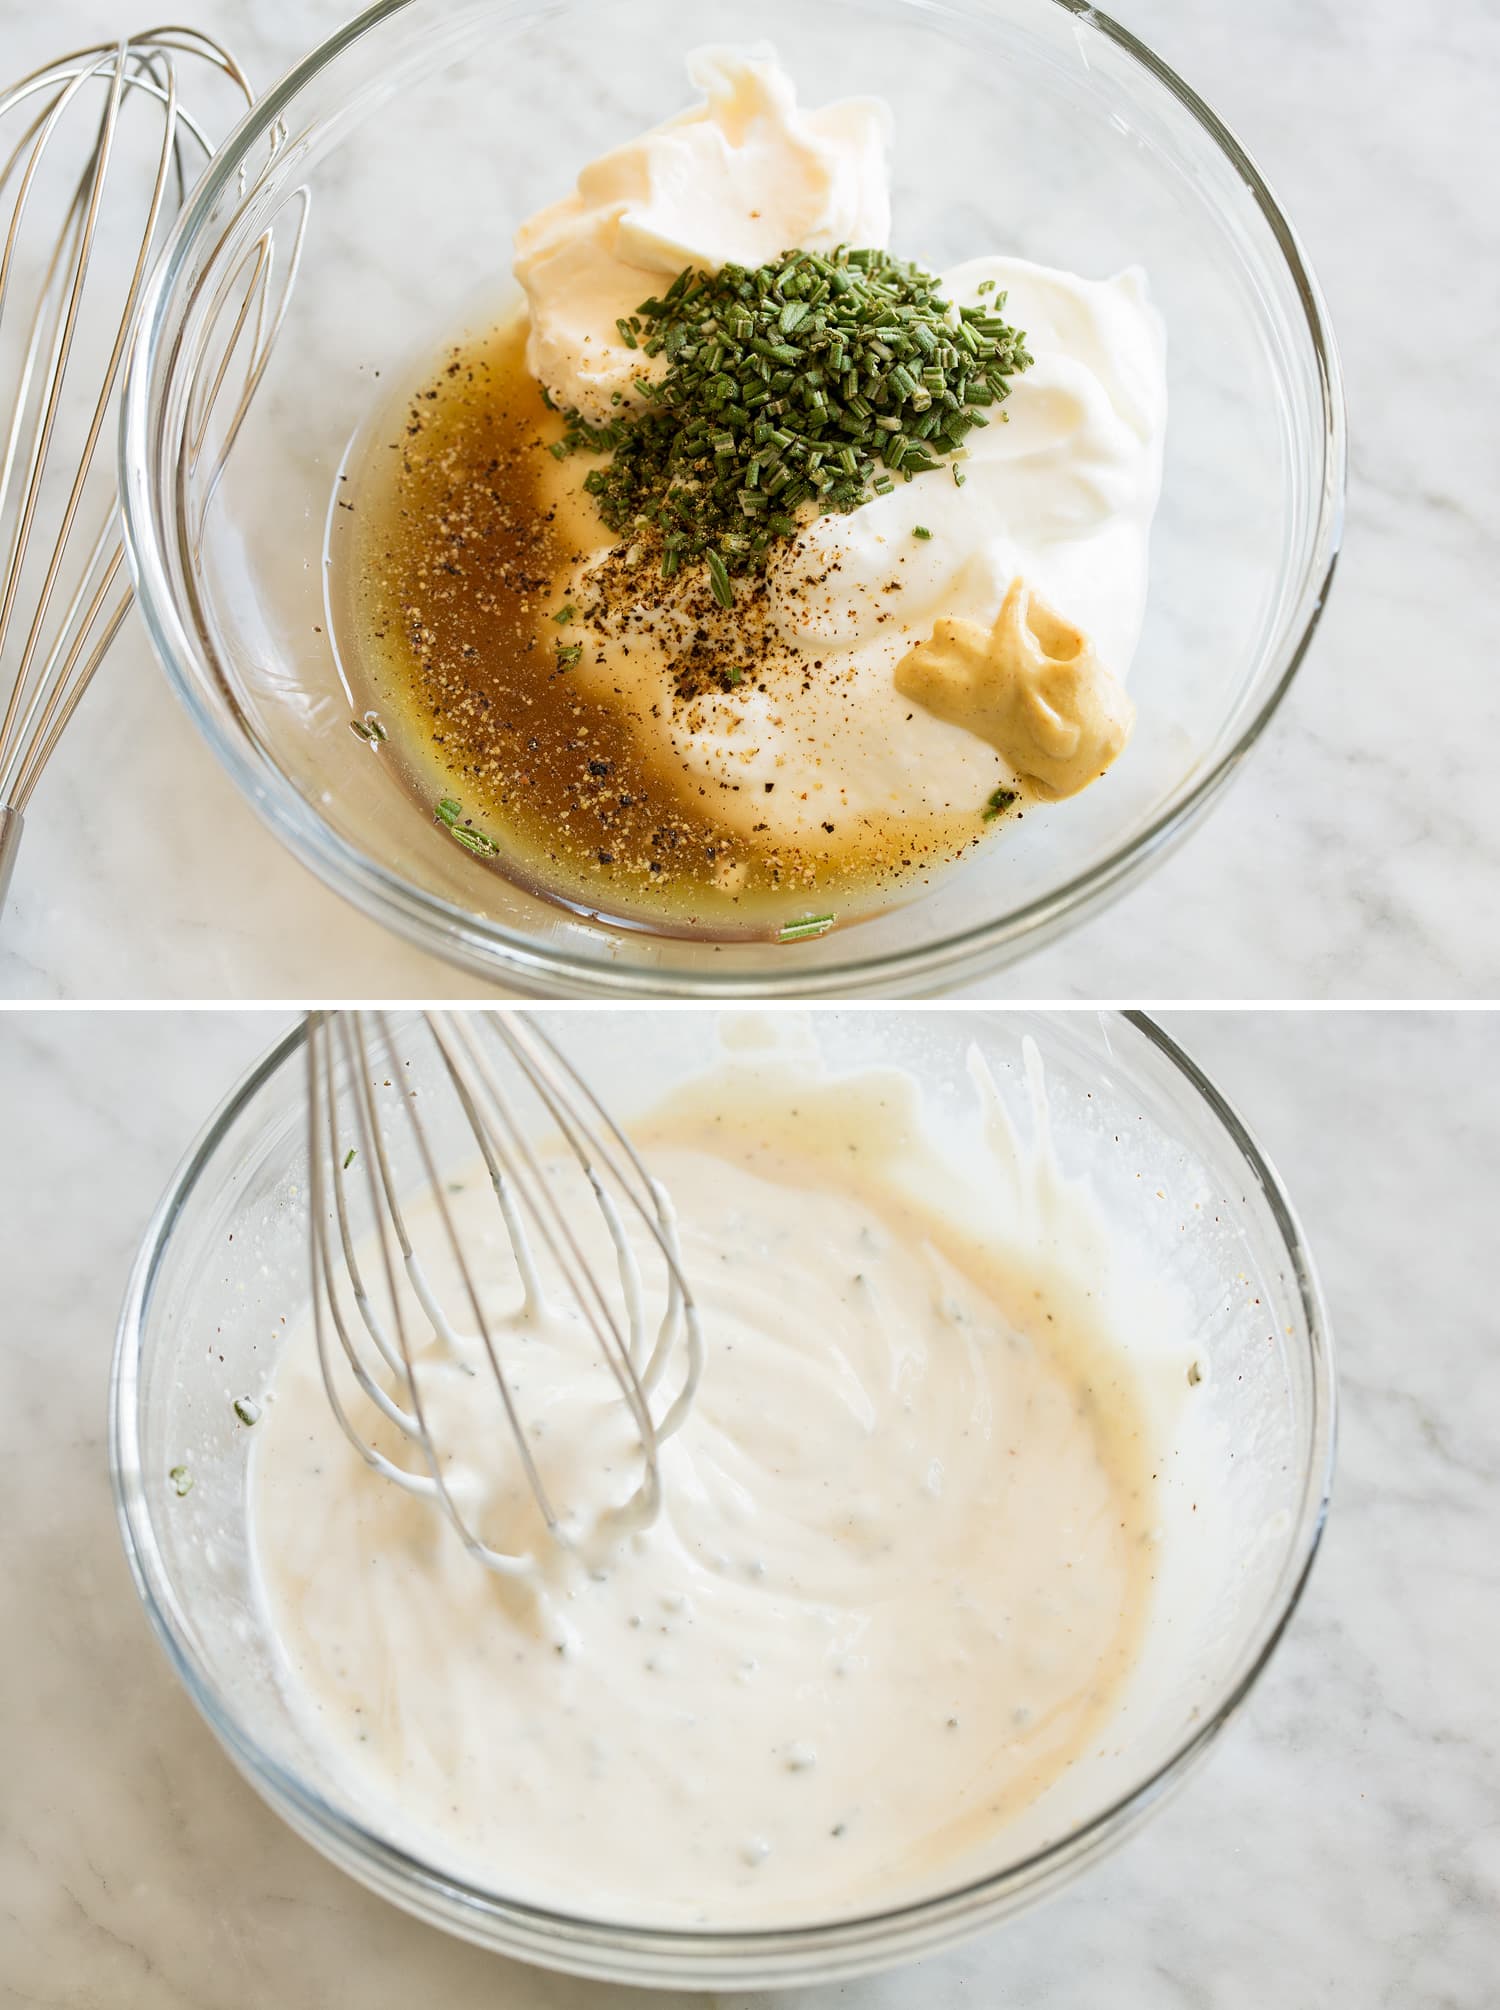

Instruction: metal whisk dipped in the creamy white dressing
[308,1011,704,1574]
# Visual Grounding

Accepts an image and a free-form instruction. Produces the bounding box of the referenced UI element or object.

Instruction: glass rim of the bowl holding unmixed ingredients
[119,0,1347,999]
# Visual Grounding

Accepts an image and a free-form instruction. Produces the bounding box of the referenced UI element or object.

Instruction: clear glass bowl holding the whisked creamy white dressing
[111,1009,1333,1988]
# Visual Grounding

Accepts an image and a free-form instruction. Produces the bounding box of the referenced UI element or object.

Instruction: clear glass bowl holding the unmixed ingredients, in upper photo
[121,0,1343,999]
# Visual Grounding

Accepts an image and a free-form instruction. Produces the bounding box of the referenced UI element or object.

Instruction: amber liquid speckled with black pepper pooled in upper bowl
[330,318,993,939]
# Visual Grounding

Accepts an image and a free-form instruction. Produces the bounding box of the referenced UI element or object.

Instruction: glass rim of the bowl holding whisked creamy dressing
[109,1007,1337,1988]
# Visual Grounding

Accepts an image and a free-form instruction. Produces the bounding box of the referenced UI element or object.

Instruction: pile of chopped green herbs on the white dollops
[553,247,1032,586]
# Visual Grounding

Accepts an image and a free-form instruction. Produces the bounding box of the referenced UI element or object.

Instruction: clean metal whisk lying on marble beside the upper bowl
[0,28,253,905]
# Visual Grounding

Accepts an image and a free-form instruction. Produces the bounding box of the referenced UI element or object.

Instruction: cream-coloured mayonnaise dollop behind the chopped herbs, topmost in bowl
[515,46,891,422]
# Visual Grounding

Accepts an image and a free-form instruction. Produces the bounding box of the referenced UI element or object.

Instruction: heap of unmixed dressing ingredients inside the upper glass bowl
[330,48,1166,939]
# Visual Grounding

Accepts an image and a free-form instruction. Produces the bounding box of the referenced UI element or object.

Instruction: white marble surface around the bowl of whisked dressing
[0,1013,1500,2010]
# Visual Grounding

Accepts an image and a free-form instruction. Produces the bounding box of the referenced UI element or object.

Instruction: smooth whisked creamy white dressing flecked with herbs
[251,1059,1154,1926]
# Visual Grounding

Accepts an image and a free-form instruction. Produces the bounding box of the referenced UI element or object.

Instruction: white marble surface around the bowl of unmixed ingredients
[0,0,1500,999]
